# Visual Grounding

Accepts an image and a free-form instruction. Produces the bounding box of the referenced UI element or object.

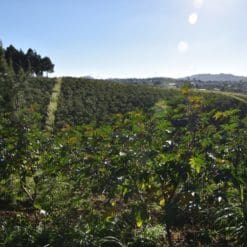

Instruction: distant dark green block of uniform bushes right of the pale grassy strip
[56,78,176,127]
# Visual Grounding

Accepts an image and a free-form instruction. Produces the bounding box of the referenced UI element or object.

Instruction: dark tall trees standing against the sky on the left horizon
[0,42,54,76]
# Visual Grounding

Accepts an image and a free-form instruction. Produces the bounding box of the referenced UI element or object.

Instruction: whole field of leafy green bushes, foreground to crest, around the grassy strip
[0,78,247,247]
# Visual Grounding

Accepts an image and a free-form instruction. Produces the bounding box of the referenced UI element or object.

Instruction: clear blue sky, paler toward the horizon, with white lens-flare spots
[0,0,247,78]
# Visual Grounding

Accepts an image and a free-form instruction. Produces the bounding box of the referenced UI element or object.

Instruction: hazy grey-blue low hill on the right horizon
[183,74,247,82]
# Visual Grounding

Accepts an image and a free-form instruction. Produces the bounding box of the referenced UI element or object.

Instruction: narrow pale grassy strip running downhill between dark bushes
[45,78,62,131]
